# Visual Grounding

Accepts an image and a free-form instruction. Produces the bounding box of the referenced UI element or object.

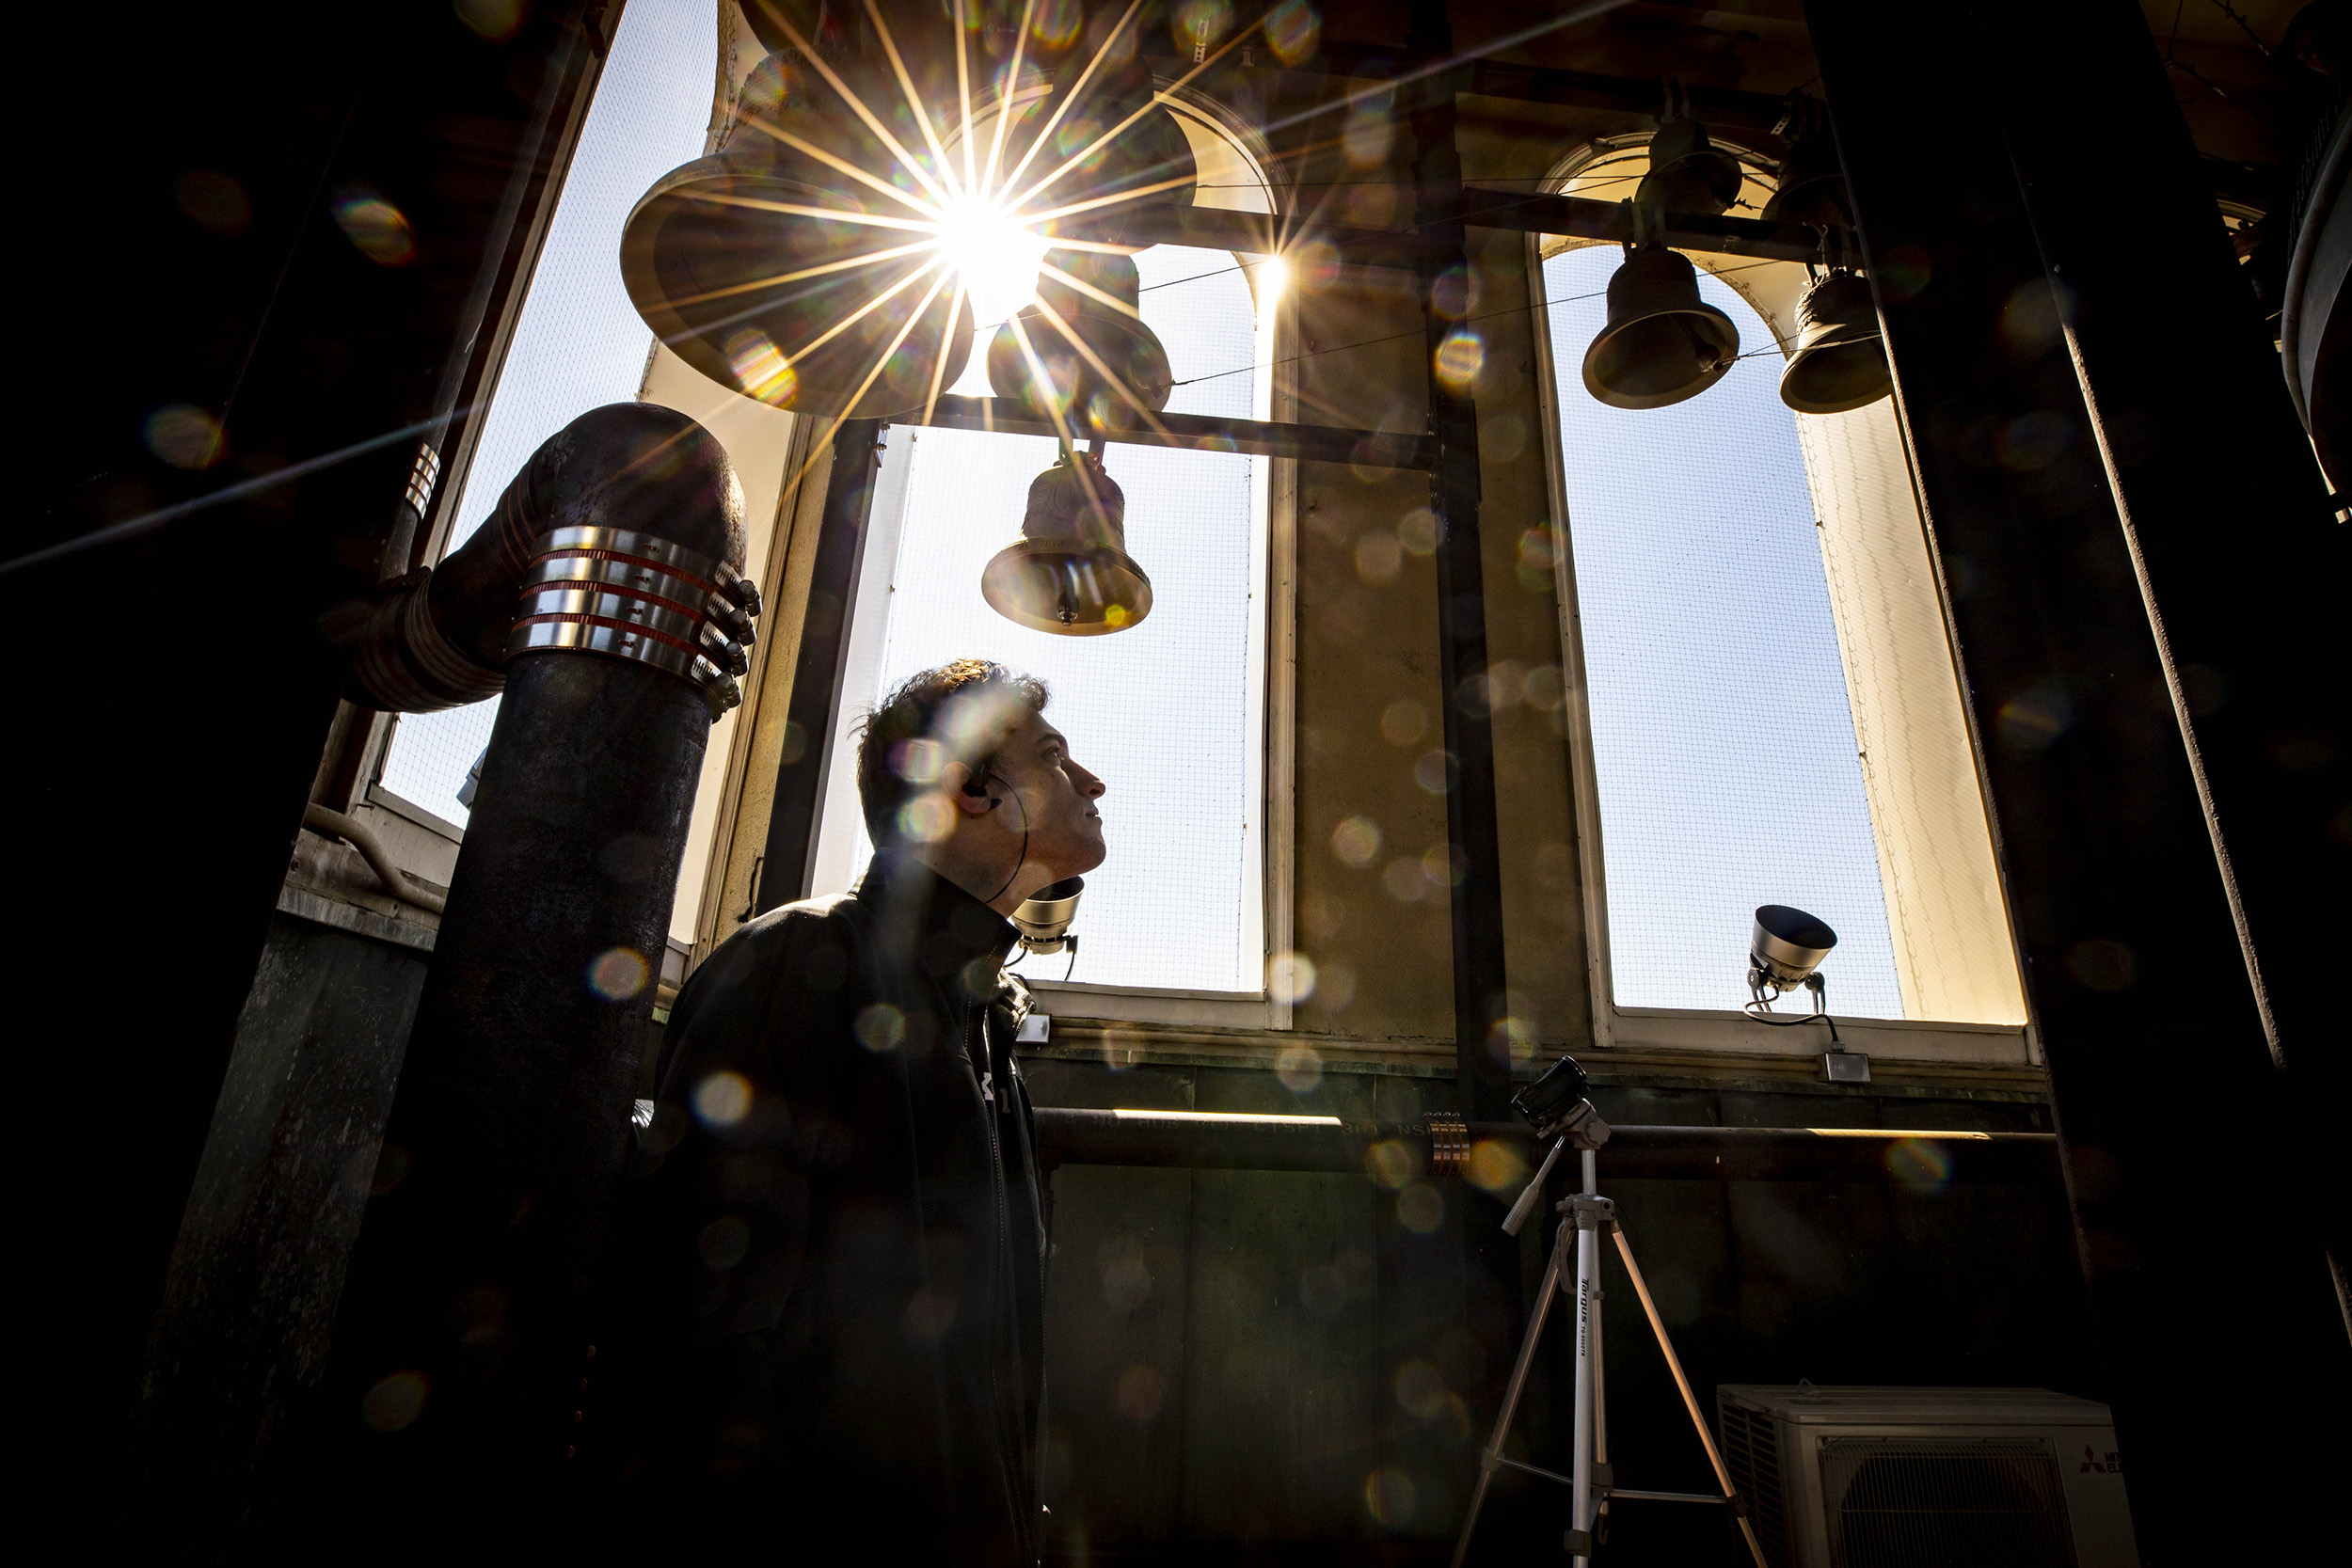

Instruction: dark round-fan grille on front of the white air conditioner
[1820,1436,2074,1568]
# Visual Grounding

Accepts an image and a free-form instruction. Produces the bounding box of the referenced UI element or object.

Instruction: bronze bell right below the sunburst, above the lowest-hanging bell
[988,249,1171,435]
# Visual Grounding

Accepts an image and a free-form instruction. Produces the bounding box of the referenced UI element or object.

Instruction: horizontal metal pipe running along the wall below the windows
[1038,1107,2058,1185]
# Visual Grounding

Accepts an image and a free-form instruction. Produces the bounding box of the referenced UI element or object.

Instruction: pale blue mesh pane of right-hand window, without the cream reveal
[1543,246,1903,1018]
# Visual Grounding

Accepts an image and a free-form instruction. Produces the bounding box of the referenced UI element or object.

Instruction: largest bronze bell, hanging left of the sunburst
[621,54,972,419]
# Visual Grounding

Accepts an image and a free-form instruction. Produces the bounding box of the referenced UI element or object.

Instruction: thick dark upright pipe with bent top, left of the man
[315,404,753,1524]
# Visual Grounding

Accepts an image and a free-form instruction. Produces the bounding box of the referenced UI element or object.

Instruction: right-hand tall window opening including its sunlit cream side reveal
[1543,246,2023,1025]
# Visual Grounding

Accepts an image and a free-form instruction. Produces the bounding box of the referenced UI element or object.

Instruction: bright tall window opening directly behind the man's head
[814,245,1275,997]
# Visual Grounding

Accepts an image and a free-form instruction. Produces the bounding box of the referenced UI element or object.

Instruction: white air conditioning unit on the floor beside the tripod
[1715,1383,2140,1568]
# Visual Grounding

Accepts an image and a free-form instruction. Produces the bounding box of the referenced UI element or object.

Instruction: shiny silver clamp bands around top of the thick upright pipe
[506,527,760,720]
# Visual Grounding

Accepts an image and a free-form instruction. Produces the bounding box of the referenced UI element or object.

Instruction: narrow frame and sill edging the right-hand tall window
[1524,223,2042,1068]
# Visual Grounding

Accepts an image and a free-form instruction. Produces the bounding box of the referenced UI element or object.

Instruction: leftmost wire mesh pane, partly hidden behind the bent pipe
[384,0,718,828]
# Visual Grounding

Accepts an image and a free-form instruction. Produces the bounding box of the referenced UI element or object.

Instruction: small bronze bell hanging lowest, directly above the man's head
[981,447,1152,637]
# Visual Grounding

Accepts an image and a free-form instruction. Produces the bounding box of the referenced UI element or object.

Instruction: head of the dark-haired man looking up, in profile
[859,658,1104,908]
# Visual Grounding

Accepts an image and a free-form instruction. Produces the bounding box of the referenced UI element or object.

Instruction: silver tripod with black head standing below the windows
[1454,1101,1767,1568]
